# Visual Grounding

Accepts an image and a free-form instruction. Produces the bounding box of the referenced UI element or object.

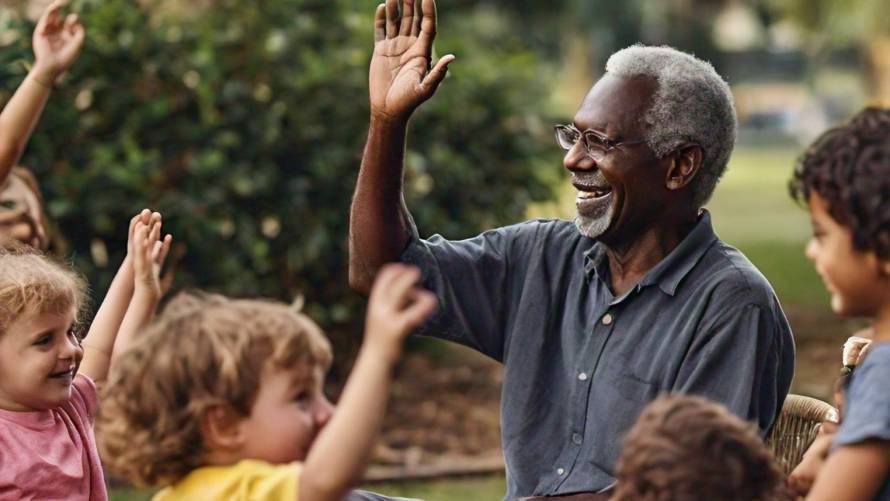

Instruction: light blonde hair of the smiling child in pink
[0,242,86,335]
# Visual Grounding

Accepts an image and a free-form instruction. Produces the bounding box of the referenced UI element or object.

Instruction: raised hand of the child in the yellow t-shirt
[365,264,436,362]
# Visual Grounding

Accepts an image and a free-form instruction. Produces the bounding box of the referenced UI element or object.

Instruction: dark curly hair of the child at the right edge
[789,107,890,259]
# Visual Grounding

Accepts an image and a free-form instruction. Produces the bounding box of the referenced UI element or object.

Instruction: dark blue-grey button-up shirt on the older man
[402,212,794,498]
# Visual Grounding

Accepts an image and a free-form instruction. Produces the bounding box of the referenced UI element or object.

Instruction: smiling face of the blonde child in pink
[0,312,83,411]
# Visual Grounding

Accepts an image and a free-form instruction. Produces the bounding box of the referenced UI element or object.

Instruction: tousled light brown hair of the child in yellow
[97,293,331,486]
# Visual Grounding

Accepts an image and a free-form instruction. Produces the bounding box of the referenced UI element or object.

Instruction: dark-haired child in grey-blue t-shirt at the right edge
[791,108,890,500]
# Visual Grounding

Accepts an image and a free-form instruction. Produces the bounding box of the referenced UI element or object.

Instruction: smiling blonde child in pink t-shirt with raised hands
[0,211,170,500]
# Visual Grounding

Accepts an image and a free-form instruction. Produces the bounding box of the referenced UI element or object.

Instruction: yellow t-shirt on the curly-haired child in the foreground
[152,459,301,501]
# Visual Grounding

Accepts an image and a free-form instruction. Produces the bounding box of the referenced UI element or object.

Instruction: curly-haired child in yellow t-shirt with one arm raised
[98,264,436,501]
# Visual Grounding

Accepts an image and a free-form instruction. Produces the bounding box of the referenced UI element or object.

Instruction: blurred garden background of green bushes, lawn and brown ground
[0,0,890,500]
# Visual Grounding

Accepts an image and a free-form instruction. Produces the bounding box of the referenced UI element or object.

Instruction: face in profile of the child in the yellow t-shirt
[241,366,334,464]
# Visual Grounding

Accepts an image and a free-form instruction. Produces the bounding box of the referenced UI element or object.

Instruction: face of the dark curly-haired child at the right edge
[806,193,888,316]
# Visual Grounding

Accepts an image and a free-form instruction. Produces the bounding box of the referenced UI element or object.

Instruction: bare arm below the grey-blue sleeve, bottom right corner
[806,440,890,501]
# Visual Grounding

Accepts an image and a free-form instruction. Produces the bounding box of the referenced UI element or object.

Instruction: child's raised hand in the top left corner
[32,0,86,85]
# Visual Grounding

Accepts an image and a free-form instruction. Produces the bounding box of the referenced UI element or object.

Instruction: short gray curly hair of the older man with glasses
[606,44,736,207]
